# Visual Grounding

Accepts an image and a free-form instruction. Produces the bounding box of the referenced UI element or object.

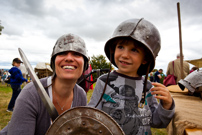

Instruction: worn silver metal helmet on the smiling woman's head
[50,33,88,74]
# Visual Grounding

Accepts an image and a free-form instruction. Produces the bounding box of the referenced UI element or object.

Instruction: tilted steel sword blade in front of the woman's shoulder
[18,48,58,121]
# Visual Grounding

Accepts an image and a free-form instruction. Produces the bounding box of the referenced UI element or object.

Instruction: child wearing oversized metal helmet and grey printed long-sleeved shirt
[88,19,175,135]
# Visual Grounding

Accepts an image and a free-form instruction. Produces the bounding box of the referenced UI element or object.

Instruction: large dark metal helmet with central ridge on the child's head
[105,19,161,75]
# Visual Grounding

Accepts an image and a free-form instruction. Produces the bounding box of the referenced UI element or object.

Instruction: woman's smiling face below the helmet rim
[55,51,84,80]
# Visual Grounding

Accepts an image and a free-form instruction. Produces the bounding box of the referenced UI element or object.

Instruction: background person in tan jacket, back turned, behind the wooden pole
[166,54,190,84]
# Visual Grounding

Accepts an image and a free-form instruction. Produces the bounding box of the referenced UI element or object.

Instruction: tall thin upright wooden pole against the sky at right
[177,2,184,79]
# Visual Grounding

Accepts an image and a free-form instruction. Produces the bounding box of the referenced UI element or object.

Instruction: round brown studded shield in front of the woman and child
[46,106,125,135]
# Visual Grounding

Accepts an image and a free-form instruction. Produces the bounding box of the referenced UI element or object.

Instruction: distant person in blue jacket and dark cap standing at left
[7,58,28,112]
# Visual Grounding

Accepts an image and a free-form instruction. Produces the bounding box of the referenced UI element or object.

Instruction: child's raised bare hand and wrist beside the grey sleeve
[150,82,173,110]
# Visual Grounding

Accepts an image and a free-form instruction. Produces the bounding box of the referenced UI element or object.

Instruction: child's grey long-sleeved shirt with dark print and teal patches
[88,71,175,135]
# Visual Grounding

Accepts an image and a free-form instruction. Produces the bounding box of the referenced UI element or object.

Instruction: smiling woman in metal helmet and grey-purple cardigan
[0,34,88,135]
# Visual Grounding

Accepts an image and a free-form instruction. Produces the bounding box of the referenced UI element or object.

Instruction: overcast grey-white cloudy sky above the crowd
[0,0,202,73]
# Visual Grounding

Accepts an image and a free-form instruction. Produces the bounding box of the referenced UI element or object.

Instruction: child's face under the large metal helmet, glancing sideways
[114,40,146,77]
